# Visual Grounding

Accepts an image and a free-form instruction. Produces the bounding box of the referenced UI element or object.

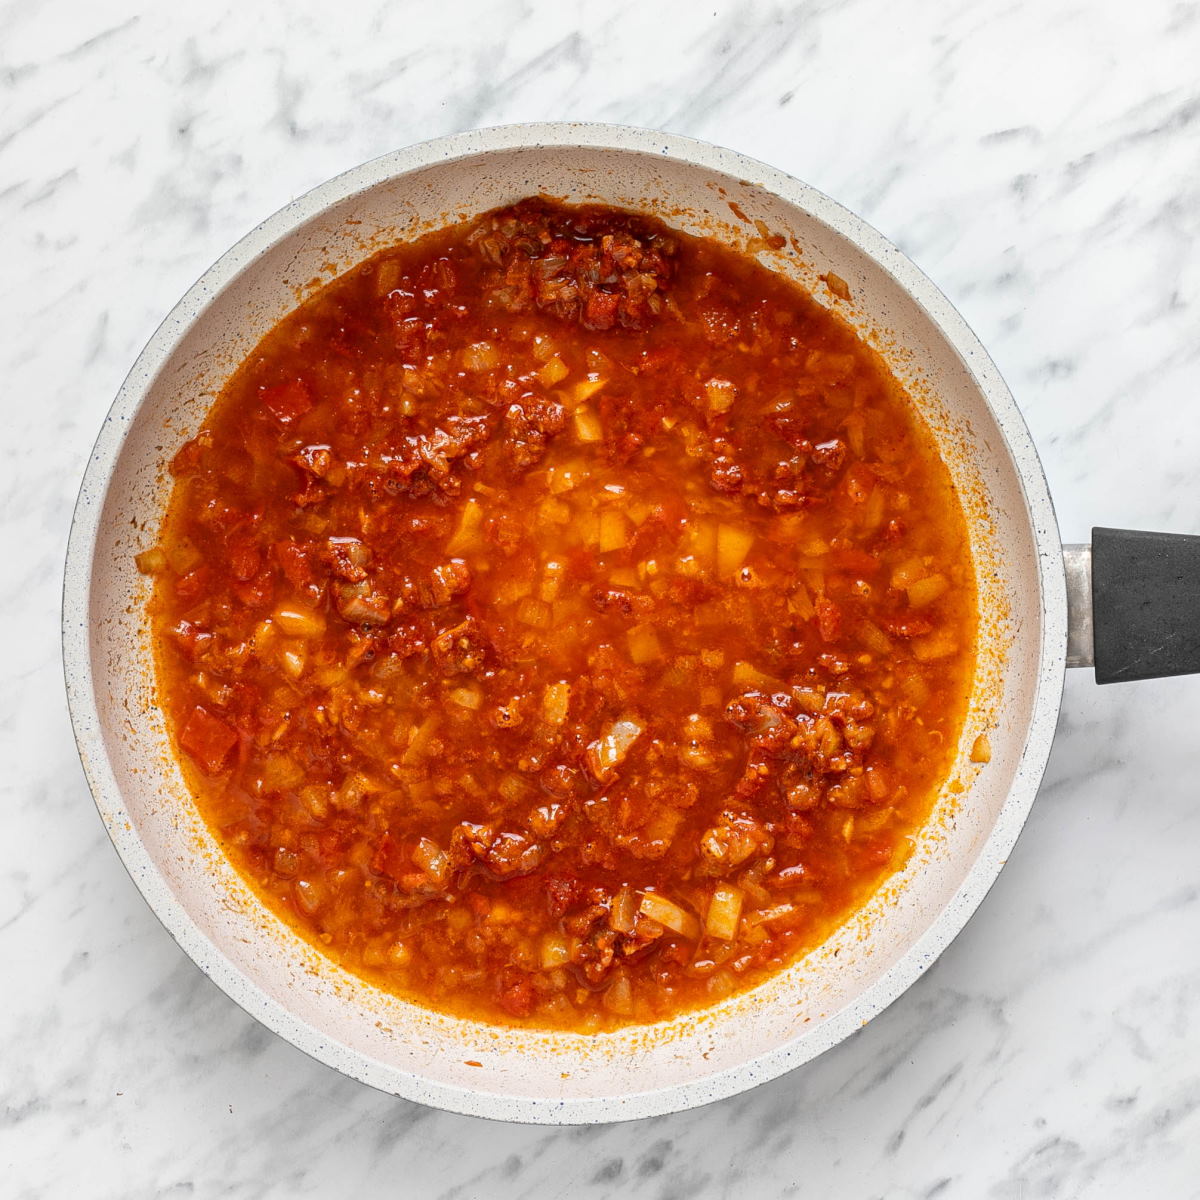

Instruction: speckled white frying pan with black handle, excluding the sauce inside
[62,124,1200,1123]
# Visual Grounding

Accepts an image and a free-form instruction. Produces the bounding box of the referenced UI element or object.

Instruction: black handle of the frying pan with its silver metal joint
[1063,528,1200,683]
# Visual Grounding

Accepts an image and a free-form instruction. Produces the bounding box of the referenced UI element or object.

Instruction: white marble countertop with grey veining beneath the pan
[9,0,1200,1200]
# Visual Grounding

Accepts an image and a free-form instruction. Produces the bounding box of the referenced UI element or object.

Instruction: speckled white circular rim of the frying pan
[62,122,1067,1124]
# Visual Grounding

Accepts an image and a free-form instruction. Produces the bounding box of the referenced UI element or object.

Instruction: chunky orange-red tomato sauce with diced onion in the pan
[139,199,976,1031]
